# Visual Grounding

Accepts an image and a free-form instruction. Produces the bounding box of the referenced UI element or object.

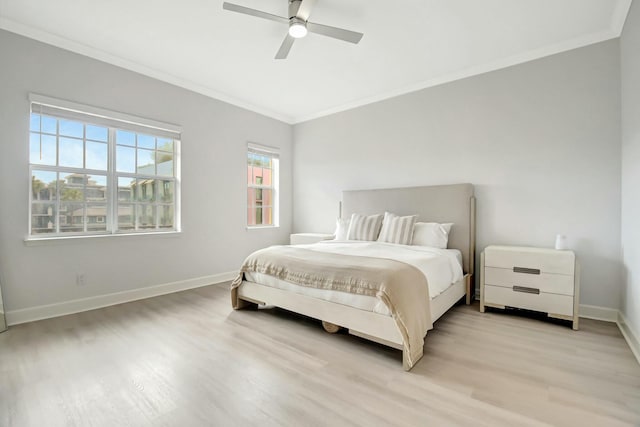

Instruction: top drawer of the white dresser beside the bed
[484,246,576,276]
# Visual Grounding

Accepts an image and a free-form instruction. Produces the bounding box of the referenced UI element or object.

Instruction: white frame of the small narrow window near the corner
[244,142,280,230]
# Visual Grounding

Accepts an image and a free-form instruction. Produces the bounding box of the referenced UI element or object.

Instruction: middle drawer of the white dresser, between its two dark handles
[484,267,574,296]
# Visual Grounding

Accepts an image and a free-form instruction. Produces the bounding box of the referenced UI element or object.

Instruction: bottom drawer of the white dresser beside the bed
[484,284,573,316]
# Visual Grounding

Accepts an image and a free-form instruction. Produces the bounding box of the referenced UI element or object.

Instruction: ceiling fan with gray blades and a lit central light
[222,0,364,59]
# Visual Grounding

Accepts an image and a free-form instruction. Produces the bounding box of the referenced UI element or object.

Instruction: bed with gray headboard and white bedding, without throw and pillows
[237,184,475,370]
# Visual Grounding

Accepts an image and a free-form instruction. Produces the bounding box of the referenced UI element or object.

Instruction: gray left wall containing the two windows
[0,31,292,311]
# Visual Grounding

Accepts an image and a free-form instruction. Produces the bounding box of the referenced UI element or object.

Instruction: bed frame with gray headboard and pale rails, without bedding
[238,184,475,370]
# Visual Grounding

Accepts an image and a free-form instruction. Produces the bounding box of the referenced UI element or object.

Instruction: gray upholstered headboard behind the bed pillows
[342,184,476,274]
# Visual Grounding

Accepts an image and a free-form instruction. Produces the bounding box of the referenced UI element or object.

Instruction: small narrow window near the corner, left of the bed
[247,144,279,227]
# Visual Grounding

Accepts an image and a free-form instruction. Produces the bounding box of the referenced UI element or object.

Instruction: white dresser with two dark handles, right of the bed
[480,246,580,330]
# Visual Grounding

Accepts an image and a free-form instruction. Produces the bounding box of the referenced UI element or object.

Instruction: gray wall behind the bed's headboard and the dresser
[293,40,621,308]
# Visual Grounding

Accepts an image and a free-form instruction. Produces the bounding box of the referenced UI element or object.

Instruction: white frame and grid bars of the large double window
[25,94,182,241]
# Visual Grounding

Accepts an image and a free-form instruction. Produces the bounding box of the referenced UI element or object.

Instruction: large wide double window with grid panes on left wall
[29,95,180,238]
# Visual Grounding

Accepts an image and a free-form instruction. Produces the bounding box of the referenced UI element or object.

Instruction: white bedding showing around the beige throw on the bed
[245,240,463,316]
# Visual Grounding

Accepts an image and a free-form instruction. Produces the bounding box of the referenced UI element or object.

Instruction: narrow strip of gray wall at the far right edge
[621,2,640,340]
